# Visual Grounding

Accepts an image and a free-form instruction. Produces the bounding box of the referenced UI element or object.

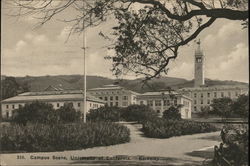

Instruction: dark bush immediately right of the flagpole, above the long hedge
[87,106,121,122]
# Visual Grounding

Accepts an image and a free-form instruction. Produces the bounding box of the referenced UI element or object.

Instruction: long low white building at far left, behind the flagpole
[1,88,106,118]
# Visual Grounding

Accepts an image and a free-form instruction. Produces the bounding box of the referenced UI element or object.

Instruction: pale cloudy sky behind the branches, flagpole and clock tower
[1,2,249,82]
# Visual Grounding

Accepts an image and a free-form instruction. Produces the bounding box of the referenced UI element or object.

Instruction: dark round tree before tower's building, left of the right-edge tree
[210,97,233,118]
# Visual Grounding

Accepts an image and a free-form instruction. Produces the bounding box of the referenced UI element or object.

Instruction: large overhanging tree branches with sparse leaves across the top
[7,0,249,80]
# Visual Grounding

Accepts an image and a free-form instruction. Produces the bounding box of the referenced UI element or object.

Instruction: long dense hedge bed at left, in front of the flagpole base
[1,122,130,152]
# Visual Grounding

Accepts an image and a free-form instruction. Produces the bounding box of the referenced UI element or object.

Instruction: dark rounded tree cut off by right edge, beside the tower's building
[231,95,249,118]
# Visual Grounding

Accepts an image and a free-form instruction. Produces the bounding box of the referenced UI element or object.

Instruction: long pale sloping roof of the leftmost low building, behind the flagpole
[2,90,105,103]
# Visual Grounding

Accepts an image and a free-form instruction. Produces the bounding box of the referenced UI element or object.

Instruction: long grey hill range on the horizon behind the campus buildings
[3,75,248,92]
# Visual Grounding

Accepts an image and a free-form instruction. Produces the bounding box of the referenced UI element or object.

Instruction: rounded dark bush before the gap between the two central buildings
[122,105,157,122]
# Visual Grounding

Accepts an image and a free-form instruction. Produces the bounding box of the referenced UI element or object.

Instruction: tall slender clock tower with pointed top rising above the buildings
[194,39,205,87]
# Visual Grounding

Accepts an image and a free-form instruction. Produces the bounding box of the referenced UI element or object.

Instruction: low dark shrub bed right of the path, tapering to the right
[142,118,216,138]
